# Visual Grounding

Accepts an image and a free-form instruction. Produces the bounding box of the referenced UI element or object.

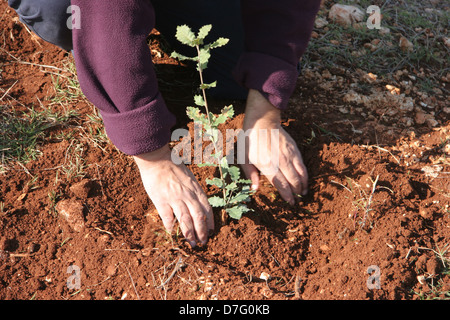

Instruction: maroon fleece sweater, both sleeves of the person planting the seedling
[72,0,320,155]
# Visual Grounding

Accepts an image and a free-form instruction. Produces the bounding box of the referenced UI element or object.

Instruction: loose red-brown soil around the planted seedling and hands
[0,1,450,300]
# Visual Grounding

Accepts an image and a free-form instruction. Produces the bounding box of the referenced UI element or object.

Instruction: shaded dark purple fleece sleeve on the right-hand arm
[234,0,320,109]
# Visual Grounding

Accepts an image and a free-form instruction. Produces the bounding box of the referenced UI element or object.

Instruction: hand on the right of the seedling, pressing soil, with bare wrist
[241,90,308,205]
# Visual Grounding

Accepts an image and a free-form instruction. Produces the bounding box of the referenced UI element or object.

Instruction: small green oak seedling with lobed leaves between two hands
[171,25,253,224]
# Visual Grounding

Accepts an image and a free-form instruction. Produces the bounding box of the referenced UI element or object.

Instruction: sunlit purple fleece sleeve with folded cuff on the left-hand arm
[72,0,175,155]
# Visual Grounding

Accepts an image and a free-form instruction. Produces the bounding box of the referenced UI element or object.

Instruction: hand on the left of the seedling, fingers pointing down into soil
[134,145,214,247]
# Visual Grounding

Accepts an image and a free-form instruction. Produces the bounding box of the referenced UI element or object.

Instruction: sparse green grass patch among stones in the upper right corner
[302,0,450,78]
